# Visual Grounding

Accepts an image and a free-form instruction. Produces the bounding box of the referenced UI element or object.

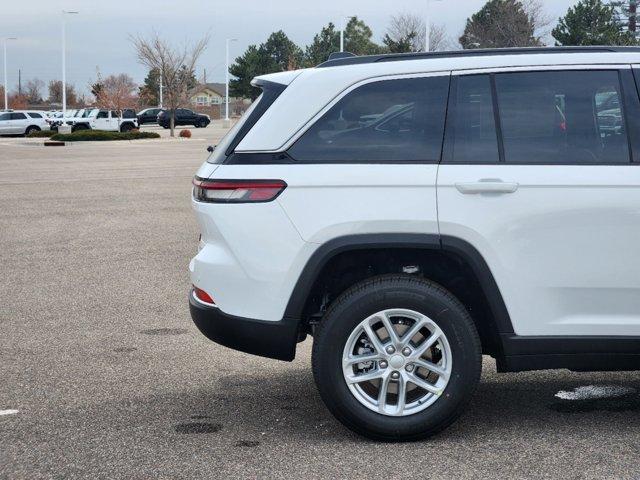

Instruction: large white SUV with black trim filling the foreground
[190,47,640,440]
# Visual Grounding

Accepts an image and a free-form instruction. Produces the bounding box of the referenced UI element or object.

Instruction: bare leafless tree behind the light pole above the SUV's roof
[387,13,452,52]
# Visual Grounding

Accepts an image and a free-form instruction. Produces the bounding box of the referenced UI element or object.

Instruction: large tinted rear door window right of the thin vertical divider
[496,71,630,164]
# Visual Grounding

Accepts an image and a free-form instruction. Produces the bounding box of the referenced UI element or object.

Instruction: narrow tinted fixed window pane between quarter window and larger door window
[448,75,500,163]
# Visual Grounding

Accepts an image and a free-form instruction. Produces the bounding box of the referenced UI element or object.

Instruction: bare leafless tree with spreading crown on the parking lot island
[131,33,209,137]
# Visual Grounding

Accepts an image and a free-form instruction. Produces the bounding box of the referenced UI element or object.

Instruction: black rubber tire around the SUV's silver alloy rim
[312,275,482,441]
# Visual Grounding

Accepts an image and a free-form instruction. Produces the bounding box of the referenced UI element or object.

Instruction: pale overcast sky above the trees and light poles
[0,0,577,95]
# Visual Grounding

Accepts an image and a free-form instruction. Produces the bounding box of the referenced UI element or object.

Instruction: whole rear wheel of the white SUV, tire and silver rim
[313,275,482,441]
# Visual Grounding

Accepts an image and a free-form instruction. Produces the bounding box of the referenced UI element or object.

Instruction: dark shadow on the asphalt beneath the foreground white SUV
[166,368,640,443]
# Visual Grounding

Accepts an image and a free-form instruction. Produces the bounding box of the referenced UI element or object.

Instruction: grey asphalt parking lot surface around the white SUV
[0,124,640,479]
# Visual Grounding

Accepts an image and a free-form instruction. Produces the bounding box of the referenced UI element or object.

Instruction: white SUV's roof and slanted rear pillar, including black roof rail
[236,47,640,152]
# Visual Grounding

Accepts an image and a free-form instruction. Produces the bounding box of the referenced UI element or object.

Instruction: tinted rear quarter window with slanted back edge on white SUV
[289,77,449,163]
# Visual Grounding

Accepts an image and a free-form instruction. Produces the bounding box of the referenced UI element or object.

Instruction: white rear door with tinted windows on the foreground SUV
[437,66,640,336]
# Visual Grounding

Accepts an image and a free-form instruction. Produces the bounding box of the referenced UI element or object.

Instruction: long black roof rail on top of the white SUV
[317,46,640,68]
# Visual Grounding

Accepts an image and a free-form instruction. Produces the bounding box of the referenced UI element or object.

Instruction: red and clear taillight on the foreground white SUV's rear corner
[193,177,287,203]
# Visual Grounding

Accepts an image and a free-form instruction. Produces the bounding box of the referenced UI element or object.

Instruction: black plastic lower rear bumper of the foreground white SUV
[189,291,298,361]
